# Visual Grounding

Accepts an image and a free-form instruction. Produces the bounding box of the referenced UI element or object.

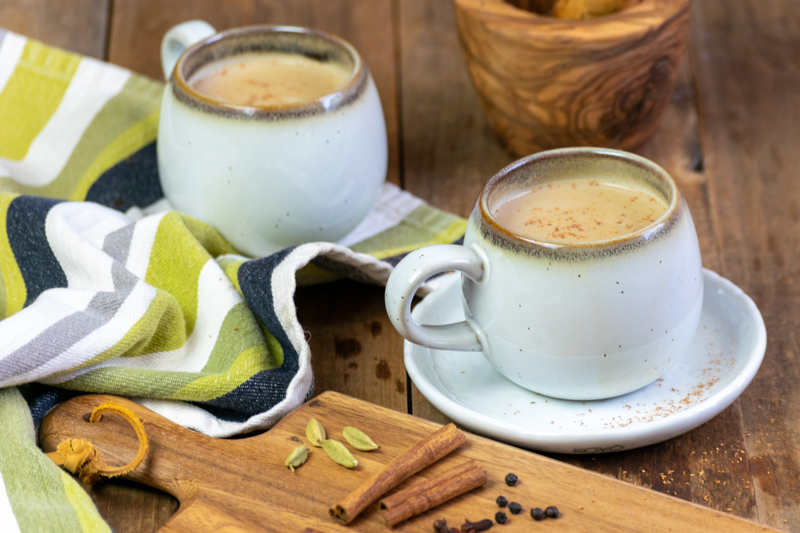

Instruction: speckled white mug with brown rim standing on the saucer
[386,148,703,400]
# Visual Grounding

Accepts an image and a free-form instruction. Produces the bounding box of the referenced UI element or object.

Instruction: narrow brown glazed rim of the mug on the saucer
[478,148,683,252]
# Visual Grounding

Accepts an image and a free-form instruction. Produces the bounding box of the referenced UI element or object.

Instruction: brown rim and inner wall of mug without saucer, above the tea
[173,26,366,115]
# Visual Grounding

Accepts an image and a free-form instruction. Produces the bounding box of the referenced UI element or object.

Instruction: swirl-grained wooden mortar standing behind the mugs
[455,0,690,155]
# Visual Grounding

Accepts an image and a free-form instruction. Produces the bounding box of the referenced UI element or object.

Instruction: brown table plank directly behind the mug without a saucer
[108,0,400,184]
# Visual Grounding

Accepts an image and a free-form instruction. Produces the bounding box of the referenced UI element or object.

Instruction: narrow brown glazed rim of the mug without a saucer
[170,25,368,120]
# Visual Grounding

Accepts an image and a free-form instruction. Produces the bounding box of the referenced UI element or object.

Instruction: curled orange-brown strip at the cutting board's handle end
[47,402,150,485]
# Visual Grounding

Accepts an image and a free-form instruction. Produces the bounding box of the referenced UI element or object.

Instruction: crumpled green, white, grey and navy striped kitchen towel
[0,30,466,533]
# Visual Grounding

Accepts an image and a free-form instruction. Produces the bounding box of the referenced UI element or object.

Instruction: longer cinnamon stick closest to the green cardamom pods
[328,424,467,524]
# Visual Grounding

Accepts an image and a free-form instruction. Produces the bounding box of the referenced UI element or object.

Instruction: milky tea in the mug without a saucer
[189,52,351,106]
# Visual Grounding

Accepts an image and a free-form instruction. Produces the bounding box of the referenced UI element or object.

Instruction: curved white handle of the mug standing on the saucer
[385,244,485,352]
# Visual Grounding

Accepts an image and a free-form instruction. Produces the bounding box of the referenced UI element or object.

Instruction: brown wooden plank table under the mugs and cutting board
[0,0,800,533]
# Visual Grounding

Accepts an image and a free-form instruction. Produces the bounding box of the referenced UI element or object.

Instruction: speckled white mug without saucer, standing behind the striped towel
[157,21,387,256]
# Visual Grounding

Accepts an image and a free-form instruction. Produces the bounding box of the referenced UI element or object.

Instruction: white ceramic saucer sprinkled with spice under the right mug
[405,270,767,453]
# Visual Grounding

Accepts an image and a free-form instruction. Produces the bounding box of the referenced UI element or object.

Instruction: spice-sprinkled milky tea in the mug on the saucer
[492,179,667,242]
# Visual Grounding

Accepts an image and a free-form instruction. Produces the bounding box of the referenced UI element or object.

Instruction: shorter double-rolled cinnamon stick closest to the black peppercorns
[380,461,489,527]
